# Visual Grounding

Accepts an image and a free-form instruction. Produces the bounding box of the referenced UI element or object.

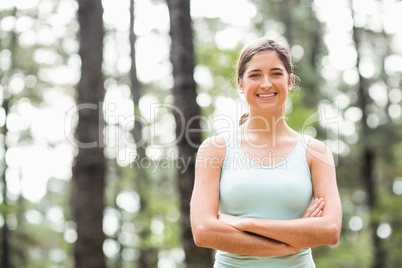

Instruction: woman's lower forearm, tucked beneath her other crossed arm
[193,220,299,256]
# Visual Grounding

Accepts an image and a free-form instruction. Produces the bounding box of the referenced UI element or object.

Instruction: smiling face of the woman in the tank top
[239,50,292,113]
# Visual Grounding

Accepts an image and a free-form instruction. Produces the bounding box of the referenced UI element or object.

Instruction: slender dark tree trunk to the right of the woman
[350,0,387,268]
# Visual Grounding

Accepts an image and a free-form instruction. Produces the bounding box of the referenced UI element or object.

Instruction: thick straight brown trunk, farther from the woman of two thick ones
[72,0,106,268]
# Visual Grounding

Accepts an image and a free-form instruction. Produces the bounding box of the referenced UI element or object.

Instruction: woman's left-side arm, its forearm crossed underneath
[190,137,299,256]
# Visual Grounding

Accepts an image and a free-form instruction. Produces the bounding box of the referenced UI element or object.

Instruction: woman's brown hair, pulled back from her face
[236,37,296,126]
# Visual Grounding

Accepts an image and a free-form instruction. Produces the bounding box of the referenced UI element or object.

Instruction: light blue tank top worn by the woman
[214,136,315,268]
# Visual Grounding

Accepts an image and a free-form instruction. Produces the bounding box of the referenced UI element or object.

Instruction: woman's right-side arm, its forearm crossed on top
[219,140,342,248]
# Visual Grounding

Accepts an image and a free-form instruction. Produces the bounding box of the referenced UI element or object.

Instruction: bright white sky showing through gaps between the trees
[0,0,402,249]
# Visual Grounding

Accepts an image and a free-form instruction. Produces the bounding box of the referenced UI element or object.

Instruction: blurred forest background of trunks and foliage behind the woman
[0,0,402,268]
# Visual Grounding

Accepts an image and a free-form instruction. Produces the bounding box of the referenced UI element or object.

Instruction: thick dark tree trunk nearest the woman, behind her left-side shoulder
[167,0,213,268]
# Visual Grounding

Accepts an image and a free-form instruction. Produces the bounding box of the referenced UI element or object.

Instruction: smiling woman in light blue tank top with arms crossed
[191,38,342,268]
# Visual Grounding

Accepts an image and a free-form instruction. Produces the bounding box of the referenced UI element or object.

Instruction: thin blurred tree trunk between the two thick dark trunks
[129,0,158,268]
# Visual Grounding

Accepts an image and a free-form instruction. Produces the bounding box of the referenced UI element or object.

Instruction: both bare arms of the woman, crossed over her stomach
[190,137,342,256]
